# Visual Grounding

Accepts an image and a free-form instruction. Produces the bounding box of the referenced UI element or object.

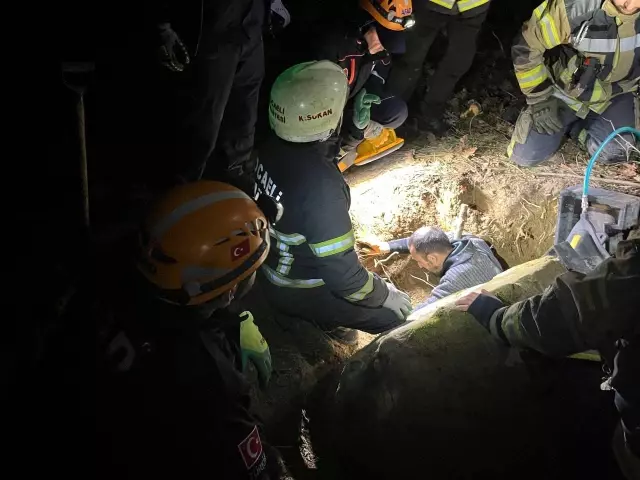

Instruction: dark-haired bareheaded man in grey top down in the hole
[359,227,508,310]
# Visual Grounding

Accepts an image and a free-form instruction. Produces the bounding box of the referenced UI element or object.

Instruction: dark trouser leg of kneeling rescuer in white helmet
[257,273,404,333]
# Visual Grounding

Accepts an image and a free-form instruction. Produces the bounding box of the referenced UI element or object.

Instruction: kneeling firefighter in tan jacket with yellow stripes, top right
[508,0,640,167]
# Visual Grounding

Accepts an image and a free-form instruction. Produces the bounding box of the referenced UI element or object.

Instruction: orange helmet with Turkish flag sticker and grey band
[138,181,269,305]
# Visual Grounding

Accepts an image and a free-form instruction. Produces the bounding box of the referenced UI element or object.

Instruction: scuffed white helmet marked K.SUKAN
[269,60,349,143]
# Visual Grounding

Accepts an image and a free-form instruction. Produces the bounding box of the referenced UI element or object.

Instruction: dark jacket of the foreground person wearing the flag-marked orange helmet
[97,288,278,480]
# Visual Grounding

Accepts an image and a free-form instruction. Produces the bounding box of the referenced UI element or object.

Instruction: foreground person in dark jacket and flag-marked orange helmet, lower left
[98,181,284,480]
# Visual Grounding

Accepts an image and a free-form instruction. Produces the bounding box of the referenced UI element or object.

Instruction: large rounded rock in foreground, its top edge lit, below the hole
[316,257,616,478]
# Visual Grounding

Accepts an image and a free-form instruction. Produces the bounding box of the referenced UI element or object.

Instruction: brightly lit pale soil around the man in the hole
[346,124,640,302]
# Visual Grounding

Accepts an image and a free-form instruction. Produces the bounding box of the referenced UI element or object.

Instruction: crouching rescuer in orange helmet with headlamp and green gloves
[317,0,414,167]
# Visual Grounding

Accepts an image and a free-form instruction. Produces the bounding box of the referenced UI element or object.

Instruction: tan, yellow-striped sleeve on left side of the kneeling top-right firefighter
[511,0,571,105]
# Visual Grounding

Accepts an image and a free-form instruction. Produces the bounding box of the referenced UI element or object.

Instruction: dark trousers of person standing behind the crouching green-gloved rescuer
[389,7,488,115]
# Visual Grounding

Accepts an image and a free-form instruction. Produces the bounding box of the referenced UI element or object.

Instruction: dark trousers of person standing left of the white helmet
[175,34,264,181]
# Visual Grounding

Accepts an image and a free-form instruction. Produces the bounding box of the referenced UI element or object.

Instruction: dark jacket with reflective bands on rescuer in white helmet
[254,135,389,307]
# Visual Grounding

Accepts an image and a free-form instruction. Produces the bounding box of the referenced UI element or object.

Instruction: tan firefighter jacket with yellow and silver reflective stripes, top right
[512,0,640,118]
